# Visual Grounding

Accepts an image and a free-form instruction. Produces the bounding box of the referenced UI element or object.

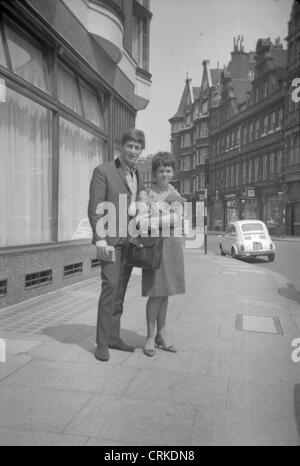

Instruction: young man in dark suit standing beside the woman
[88,129,145,361]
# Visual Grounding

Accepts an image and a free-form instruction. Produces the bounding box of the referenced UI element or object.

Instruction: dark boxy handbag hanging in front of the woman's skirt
[127,237,163,270]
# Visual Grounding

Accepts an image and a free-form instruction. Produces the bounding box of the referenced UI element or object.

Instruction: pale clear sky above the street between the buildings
[136,0,293,155]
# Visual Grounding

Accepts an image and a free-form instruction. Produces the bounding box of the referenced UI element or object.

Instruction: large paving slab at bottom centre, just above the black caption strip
[66,396,195,445]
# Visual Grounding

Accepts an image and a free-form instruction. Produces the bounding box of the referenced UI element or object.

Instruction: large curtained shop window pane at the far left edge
[0,89,52,247]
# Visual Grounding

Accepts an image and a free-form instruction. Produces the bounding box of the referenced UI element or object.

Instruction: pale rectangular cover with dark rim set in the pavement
[235,314,284,335]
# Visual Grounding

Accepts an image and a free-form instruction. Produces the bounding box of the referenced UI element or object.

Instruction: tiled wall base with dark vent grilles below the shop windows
[0,244,101,309]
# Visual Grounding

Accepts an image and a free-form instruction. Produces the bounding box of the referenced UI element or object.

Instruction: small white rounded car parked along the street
[220,220,276,262]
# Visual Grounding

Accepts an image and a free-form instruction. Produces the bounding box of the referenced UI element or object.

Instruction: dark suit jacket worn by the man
[88,159,143,246]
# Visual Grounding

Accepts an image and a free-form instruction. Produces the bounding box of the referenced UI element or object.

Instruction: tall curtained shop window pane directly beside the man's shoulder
[58,118,106,241]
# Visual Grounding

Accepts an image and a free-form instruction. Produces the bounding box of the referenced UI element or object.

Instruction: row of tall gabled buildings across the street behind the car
[169,1,300,235]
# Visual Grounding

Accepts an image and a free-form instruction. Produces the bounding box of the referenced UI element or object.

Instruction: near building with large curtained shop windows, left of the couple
[0,0,152,308]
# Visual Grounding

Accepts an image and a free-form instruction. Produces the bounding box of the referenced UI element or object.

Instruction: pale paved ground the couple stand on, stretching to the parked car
[0,244,300,446]
